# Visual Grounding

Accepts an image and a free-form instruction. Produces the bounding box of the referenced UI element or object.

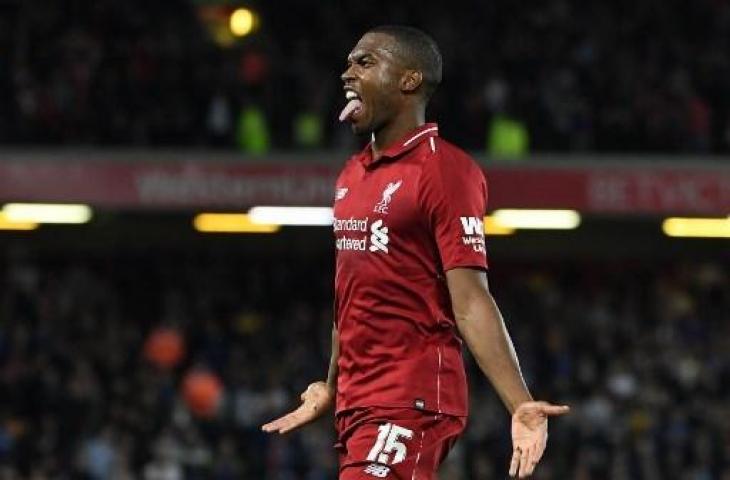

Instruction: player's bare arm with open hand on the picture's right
[446,268,569,478]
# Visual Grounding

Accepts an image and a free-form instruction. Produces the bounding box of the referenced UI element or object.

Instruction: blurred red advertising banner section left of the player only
[0,162,337,208]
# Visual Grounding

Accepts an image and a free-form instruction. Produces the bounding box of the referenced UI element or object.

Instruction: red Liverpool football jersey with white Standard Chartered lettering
[334,124,487,416]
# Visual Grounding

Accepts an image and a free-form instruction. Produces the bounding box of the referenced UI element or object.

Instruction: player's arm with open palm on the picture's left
[261,326,340,433]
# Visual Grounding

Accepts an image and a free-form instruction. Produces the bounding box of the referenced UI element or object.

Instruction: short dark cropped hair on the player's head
[368,25,443,100]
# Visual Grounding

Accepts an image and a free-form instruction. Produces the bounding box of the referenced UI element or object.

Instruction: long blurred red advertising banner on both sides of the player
[0,159,730,215]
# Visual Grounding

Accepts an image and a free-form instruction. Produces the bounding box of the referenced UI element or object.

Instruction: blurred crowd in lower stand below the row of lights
[0,246,730,480]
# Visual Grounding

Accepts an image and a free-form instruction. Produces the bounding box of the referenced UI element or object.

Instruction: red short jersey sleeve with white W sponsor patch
[419,148,487,271]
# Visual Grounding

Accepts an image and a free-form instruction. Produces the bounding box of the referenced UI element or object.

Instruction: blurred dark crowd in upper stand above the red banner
[0,0,730,154]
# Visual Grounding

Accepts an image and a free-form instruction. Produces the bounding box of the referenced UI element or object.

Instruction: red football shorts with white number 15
[335,407,466,480]
